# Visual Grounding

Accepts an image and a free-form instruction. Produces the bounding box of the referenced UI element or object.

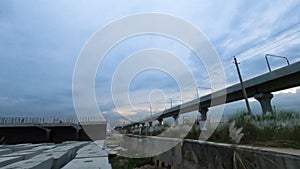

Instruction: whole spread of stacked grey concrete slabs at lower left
[0,141,111,169]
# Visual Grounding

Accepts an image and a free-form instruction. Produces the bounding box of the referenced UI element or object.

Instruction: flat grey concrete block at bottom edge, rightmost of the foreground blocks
[62,157,111,169]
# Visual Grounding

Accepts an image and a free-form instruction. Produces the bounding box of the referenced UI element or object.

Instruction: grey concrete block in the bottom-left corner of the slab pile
[2,155,53,169]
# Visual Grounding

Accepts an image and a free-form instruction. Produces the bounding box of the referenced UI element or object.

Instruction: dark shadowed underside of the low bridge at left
[0,122,106,144]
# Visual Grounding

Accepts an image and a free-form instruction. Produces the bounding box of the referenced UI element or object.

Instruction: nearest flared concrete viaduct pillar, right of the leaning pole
[254,93,273,115]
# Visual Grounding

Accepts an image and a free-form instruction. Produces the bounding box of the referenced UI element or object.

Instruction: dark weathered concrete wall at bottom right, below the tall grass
[144,139,300,169]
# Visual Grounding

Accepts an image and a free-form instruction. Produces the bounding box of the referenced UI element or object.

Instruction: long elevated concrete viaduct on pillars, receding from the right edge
[116,62,300,129]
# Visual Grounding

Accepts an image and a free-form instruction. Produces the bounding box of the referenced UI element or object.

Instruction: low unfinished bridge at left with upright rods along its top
[0,117,106,144]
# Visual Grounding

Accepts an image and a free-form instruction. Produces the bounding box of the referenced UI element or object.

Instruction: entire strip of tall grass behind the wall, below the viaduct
[128,111,300,149]
